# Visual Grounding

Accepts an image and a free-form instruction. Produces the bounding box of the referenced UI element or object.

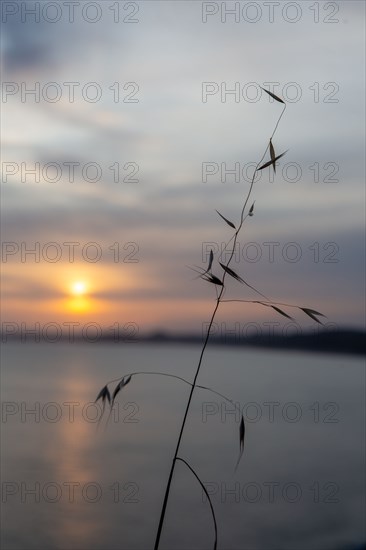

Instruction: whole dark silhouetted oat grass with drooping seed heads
[96,88,325,550]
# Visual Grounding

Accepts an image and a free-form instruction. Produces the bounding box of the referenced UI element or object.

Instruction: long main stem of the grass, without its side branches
[154,105,286,550]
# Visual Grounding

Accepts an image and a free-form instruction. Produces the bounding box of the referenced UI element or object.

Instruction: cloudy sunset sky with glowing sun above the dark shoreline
[1,0,365,338]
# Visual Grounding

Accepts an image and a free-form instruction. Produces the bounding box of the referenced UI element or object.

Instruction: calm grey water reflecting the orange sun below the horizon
[2,343,365,550]
